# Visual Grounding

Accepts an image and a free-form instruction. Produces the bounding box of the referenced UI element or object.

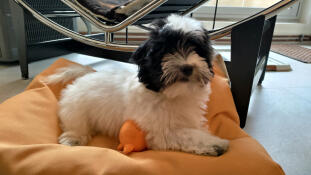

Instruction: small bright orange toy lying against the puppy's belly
[118,120,147,154]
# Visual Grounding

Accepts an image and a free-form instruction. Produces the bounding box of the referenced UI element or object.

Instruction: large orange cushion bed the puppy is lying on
[0,59,284,175]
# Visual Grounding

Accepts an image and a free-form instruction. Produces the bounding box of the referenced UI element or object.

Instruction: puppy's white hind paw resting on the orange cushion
[58,131,90,146]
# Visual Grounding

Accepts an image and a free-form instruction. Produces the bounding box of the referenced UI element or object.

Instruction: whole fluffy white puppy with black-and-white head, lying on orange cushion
[46,15,228,155]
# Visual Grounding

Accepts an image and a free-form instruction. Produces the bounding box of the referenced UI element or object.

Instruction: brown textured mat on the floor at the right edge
[271,44,311,63]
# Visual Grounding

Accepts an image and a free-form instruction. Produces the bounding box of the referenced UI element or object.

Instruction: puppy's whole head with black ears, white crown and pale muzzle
[132,15,213,97]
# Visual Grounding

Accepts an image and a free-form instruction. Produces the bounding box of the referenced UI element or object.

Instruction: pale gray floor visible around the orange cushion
[0,48,311,175]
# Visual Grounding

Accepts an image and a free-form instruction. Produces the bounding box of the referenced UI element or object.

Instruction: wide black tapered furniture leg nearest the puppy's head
[228,16,265,128]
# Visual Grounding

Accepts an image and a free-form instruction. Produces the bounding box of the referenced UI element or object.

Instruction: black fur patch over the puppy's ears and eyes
[131,15,212,92]
